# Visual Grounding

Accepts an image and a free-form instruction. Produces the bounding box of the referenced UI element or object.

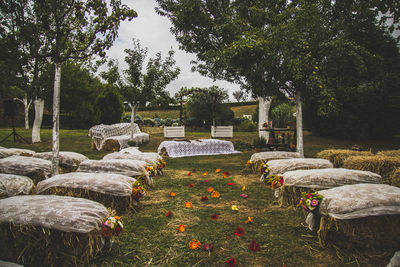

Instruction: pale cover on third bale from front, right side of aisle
[267,158,333,174]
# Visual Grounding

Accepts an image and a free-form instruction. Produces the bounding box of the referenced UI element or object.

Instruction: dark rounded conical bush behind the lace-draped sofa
[94,85,123,124]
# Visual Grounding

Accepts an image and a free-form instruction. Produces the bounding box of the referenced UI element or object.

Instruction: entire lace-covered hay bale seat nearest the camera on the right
[314,184,400,250]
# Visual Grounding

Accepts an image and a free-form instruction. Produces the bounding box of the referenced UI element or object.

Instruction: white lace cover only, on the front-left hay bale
[0,195,108,233]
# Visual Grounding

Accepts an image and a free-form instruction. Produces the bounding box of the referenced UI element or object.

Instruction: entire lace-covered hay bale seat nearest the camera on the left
[0,195,108,266]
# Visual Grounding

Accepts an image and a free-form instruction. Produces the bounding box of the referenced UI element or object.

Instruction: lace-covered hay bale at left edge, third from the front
[0,156,51,184]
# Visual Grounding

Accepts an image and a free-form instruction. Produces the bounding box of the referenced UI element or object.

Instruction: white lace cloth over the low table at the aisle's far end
[158,139,240,158]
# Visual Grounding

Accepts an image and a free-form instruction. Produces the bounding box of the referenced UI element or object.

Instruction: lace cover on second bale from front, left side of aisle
[37,172,136,196]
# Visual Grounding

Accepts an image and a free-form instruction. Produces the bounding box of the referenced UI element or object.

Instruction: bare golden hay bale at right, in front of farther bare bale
[343,155,400,184]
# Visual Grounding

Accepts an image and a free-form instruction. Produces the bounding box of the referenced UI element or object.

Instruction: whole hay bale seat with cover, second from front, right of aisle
[279,168,382,206]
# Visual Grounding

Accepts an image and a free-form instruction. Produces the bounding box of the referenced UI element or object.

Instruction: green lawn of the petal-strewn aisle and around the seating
[0,128,400,266]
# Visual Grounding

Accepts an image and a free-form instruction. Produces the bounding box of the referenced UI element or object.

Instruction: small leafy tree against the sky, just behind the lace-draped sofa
[121,39,180,138]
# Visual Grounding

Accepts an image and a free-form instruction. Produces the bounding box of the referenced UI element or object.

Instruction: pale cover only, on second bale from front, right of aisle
[283,168,382,189]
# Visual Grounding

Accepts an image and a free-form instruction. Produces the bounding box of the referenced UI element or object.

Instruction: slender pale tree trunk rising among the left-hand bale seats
[51,62,61,176]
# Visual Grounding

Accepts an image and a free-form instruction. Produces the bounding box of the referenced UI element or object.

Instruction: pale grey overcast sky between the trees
[103,0,239,100]
